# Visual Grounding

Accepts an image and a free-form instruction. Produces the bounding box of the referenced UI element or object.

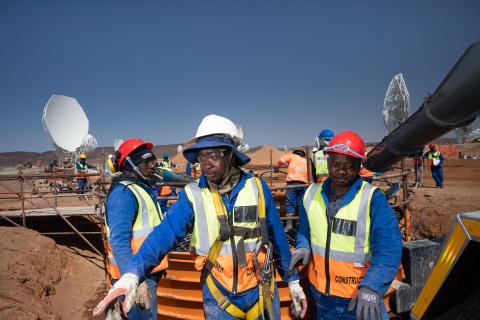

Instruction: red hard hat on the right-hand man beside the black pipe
[323,131,365,160]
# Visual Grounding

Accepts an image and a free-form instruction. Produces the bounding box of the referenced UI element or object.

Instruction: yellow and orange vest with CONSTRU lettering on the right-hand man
[303,181,376,298]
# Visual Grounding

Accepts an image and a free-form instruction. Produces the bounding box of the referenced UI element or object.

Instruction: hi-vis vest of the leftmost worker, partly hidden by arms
[105,181,168,279]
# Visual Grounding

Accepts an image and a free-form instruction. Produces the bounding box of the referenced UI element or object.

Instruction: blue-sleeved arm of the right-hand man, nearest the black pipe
[360,189,402,296]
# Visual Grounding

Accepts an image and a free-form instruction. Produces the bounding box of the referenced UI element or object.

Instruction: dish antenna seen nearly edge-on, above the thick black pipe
[383,73,410,133]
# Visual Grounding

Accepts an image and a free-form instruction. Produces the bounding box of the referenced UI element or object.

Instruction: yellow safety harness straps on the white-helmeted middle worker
[200,178,274,320]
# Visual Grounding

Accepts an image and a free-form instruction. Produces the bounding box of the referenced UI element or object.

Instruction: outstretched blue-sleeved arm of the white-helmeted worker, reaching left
[128,190,194,277]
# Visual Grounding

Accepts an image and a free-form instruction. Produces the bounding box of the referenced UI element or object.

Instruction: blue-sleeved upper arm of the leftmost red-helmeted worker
[106,184,138,274]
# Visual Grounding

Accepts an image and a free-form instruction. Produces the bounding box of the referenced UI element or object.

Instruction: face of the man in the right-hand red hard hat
[327,152,360,187]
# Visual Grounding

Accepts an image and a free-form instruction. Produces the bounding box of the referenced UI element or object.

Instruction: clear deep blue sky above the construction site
[0,0,480,151]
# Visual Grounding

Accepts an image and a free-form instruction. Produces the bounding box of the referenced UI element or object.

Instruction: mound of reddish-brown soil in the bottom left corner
[0,227,105,320]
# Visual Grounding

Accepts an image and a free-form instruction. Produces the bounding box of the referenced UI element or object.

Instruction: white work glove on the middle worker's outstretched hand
[93,273,139,320]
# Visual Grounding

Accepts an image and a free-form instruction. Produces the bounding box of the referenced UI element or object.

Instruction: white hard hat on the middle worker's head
[195,114,243,146]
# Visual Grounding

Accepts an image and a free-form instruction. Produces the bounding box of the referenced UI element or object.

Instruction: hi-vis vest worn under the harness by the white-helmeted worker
[185,178,265,293]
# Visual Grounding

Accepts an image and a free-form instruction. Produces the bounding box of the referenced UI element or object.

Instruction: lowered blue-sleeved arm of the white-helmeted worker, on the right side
[261,180,299,282]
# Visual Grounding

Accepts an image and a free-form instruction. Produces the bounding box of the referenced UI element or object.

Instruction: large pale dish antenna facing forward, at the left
[42,95,97,158]
